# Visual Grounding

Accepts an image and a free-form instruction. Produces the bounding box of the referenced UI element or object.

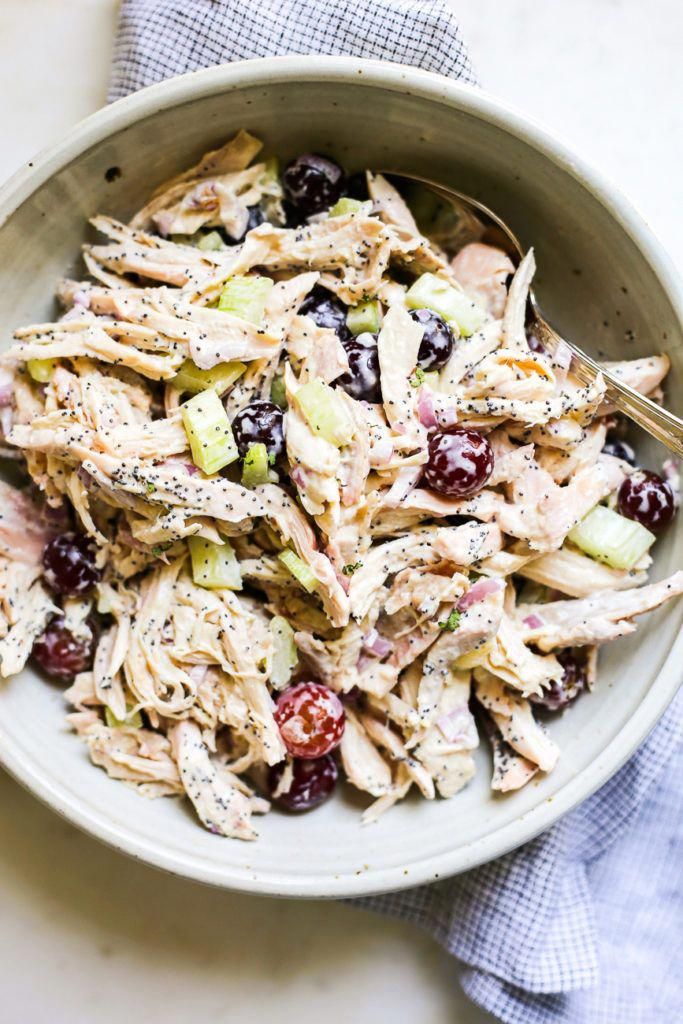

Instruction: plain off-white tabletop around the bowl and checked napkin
[0,0,683,1024]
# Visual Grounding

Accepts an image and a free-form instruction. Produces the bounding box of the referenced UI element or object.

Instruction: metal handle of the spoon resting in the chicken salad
[535,322,683,458]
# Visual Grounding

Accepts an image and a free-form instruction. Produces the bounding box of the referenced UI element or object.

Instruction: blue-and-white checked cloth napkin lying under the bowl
[111,0,683,1024]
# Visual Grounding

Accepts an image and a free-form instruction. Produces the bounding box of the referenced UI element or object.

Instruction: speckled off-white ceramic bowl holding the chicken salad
[0,56,683,896]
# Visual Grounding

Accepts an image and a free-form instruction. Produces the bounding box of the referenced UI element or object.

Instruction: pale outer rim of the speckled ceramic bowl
[0,55,683,898]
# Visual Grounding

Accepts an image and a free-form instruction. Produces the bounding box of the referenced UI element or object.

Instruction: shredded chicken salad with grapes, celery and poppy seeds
[0,131,683,840]
